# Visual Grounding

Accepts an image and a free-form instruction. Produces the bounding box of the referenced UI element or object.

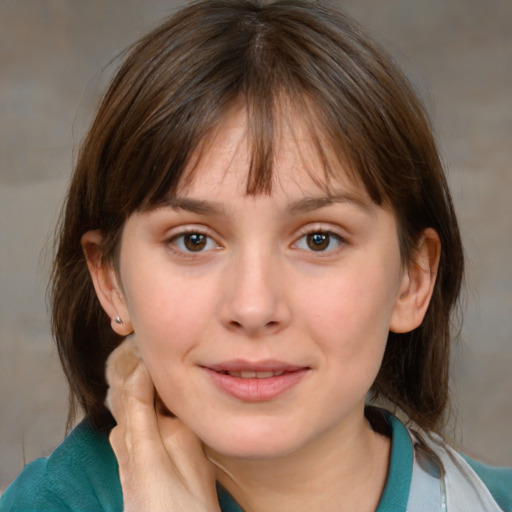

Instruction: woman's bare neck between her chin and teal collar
[208,408,391,512]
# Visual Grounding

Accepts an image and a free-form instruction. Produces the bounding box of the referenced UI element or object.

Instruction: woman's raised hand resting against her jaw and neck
[107,335,220,512]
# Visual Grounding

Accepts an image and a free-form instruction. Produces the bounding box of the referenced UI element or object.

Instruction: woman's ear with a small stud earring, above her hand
[81,230,133,336]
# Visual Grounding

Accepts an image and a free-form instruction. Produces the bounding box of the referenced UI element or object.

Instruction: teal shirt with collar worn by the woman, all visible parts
[0,414,512,512]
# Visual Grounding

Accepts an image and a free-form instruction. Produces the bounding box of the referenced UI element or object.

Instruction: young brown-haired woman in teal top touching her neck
[2,0,512,512]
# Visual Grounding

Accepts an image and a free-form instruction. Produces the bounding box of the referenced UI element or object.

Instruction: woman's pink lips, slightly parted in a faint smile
[202,360,310,402]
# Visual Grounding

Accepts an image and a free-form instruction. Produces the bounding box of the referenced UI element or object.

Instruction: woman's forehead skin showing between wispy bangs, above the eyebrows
[176,108,372,204]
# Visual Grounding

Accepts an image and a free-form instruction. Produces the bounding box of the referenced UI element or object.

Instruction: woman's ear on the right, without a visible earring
[389,228,441,333]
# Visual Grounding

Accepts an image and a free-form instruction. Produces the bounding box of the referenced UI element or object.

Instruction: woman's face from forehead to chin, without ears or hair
[113,114,404,457]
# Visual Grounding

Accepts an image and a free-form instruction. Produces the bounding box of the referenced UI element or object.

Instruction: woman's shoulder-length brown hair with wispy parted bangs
[51,0,463,429]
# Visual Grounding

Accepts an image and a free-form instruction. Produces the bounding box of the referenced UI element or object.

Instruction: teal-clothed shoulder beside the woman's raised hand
[1,421,122,512]
